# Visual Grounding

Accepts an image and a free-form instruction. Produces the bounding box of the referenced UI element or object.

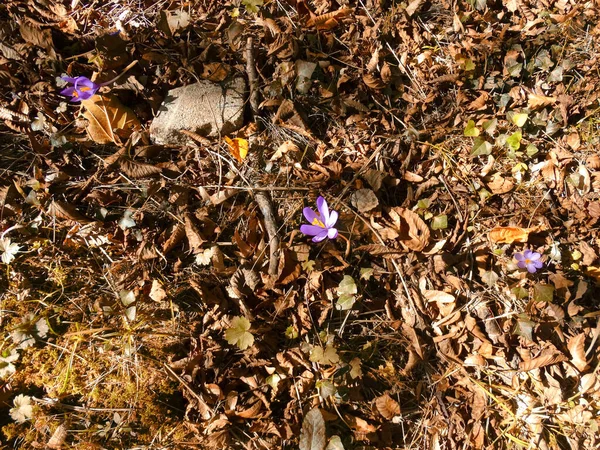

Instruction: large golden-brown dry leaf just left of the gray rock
[81,95,141,144]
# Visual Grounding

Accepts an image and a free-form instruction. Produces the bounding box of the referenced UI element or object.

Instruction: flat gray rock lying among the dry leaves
[150,77,246,144]
